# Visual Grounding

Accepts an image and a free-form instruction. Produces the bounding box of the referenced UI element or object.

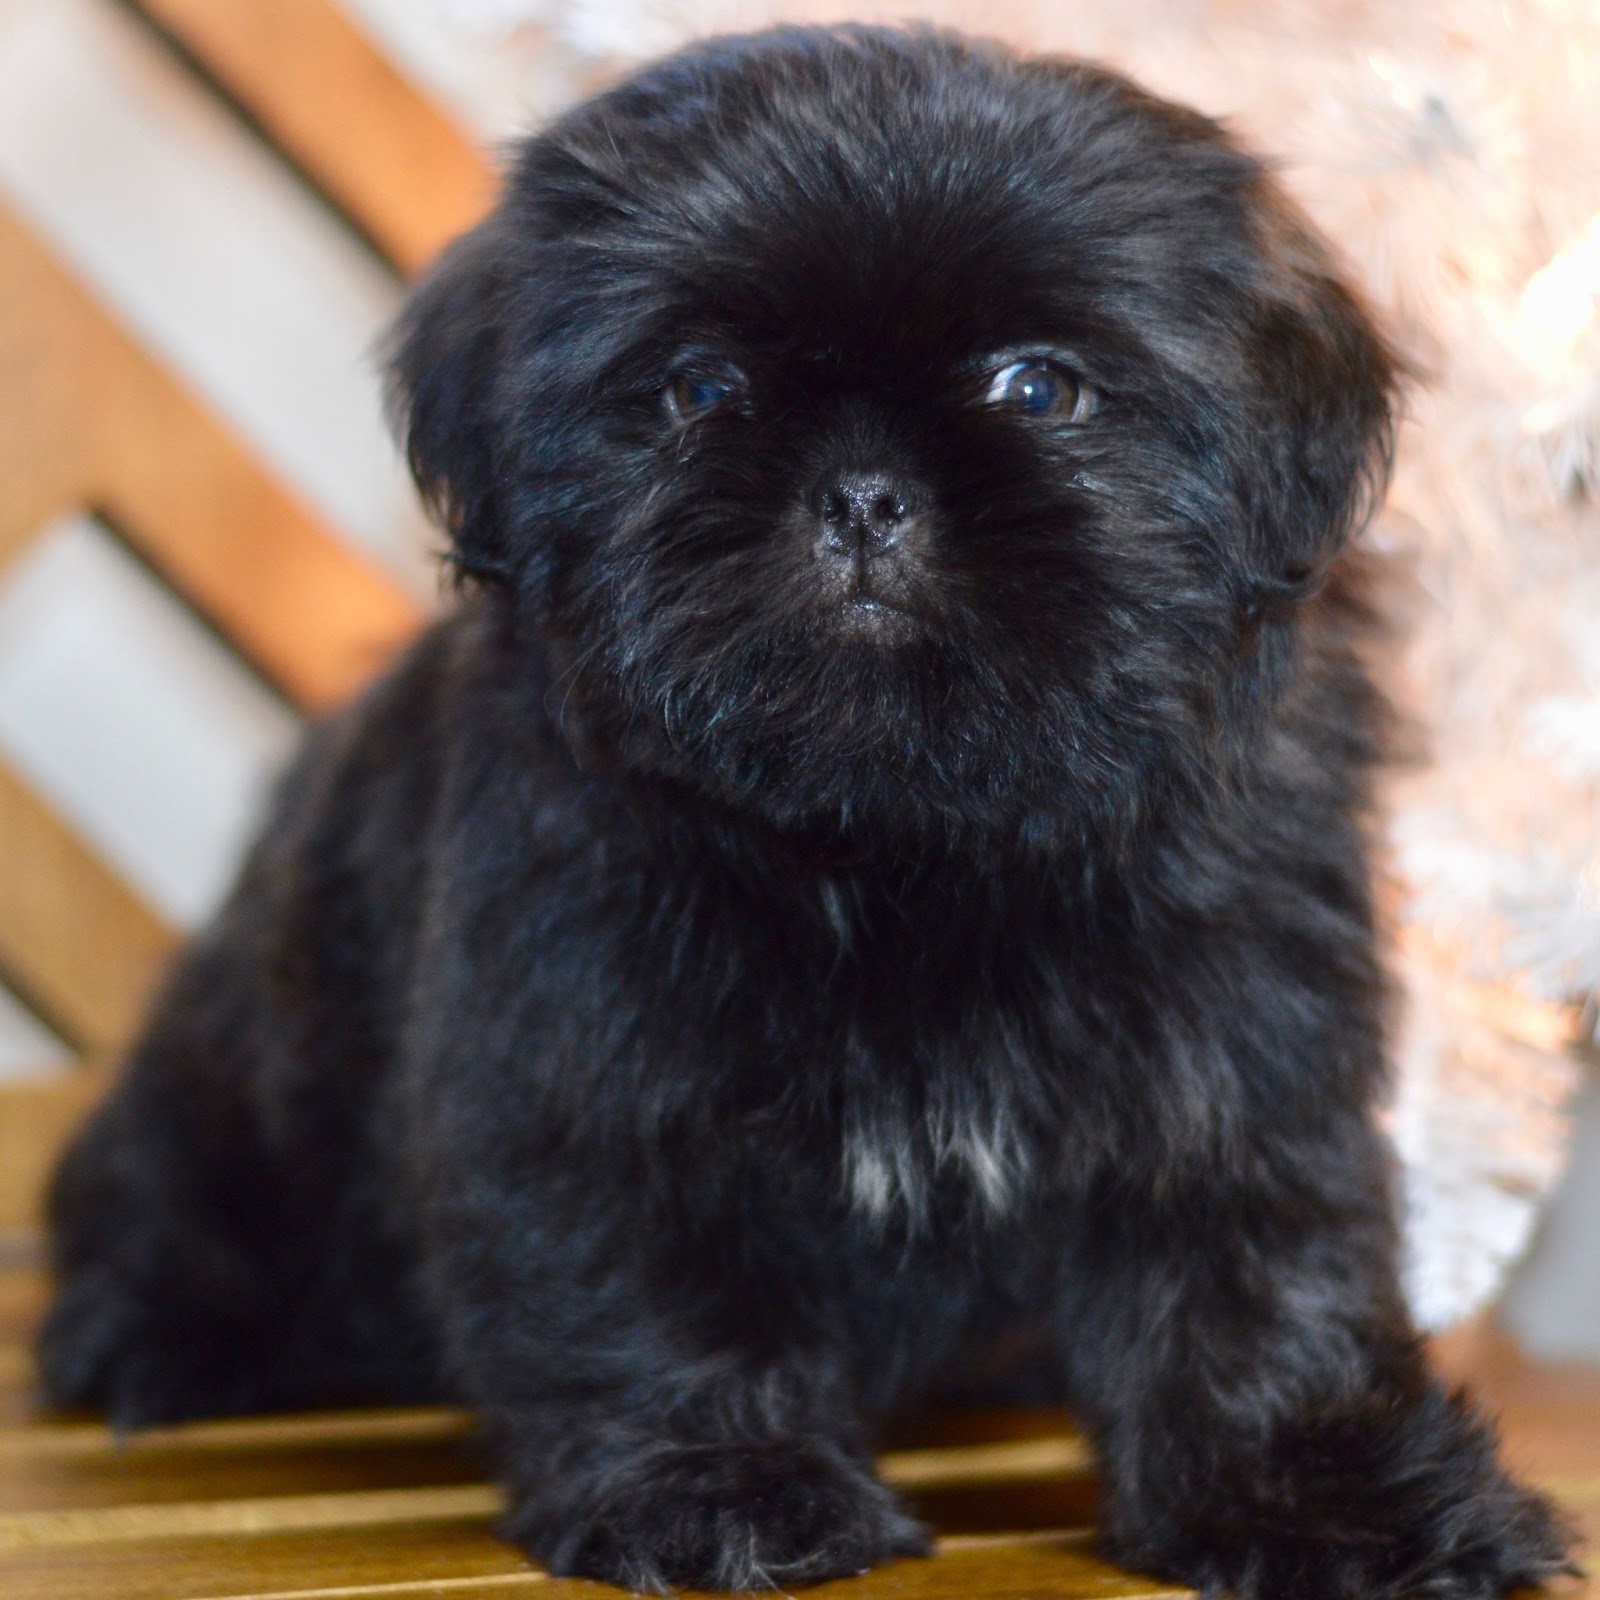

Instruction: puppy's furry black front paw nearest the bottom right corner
[1107,1392,1571,1600]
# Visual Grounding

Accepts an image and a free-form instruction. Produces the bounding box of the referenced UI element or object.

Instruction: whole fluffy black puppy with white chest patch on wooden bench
[43,30,1563,1600]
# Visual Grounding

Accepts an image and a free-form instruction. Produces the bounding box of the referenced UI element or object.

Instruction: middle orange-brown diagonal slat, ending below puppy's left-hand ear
[0,206,421,707]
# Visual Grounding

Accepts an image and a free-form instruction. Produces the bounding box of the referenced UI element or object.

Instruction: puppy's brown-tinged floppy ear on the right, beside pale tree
[1235,179,1400,610]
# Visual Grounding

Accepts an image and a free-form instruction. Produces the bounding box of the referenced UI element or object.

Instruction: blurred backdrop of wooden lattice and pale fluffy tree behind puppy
[0,0,1600,1362]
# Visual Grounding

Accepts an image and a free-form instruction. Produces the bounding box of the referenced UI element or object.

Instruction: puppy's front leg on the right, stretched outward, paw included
[1064,1128,1568,1600]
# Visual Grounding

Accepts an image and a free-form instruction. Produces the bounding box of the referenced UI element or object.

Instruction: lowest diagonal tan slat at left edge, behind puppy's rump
[0,762,174,1062]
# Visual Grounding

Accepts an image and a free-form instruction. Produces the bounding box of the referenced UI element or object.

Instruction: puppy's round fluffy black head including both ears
[395,29,1392,838]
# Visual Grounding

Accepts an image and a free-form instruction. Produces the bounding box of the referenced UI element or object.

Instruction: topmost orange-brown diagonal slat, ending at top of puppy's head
[136,0,493,272]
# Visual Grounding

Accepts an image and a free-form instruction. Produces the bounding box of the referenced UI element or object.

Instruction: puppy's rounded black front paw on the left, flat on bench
[507,1443,930,1594]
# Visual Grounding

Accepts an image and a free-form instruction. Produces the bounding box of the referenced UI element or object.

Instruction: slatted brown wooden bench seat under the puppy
[0,1269,1600,1600]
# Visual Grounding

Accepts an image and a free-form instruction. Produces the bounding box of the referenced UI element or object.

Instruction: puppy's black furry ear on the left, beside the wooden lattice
[386,214,510,581]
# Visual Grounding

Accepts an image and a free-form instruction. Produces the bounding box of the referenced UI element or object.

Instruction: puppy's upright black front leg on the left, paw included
[412,1100,928,1594]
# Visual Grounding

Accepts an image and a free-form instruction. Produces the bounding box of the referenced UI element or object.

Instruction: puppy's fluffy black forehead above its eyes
[537,30,1258,358]
